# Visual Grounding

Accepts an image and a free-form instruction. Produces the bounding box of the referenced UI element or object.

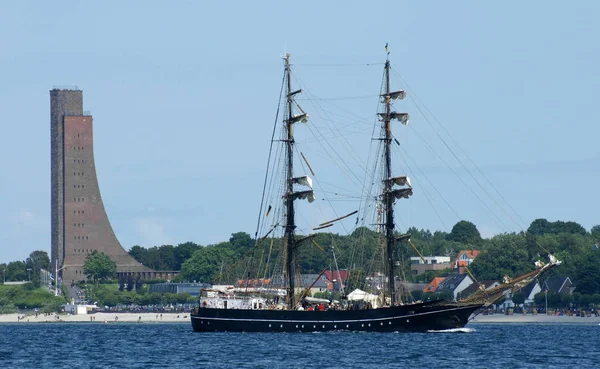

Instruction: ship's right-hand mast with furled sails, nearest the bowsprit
[379,44,412,305]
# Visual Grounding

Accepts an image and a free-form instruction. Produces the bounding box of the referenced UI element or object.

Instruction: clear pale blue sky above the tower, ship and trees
[0,0,600,262]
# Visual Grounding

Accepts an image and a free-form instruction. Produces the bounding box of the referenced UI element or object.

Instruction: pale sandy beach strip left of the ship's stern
[0,313,190,324]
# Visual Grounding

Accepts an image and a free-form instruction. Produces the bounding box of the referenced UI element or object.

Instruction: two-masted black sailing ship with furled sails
[191,46,496,332]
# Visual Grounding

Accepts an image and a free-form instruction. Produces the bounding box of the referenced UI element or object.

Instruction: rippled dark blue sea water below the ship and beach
[0,323,600,369]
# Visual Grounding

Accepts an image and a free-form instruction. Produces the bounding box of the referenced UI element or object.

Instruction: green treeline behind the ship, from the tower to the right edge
[130,219,600,294]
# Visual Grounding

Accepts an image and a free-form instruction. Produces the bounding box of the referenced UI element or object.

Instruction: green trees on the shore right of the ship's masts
[410,219,600,294]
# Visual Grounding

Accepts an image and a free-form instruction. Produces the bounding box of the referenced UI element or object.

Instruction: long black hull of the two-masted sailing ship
[191,302,482,332]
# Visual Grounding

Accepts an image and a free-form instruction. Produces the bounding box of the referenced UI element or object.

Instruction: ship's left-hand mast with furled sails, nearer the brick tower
[283,54,314,310]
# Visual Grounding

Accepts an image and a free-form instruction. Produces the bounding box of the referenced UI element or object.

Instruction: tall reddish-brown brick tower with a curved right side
[50,89,152,282]
